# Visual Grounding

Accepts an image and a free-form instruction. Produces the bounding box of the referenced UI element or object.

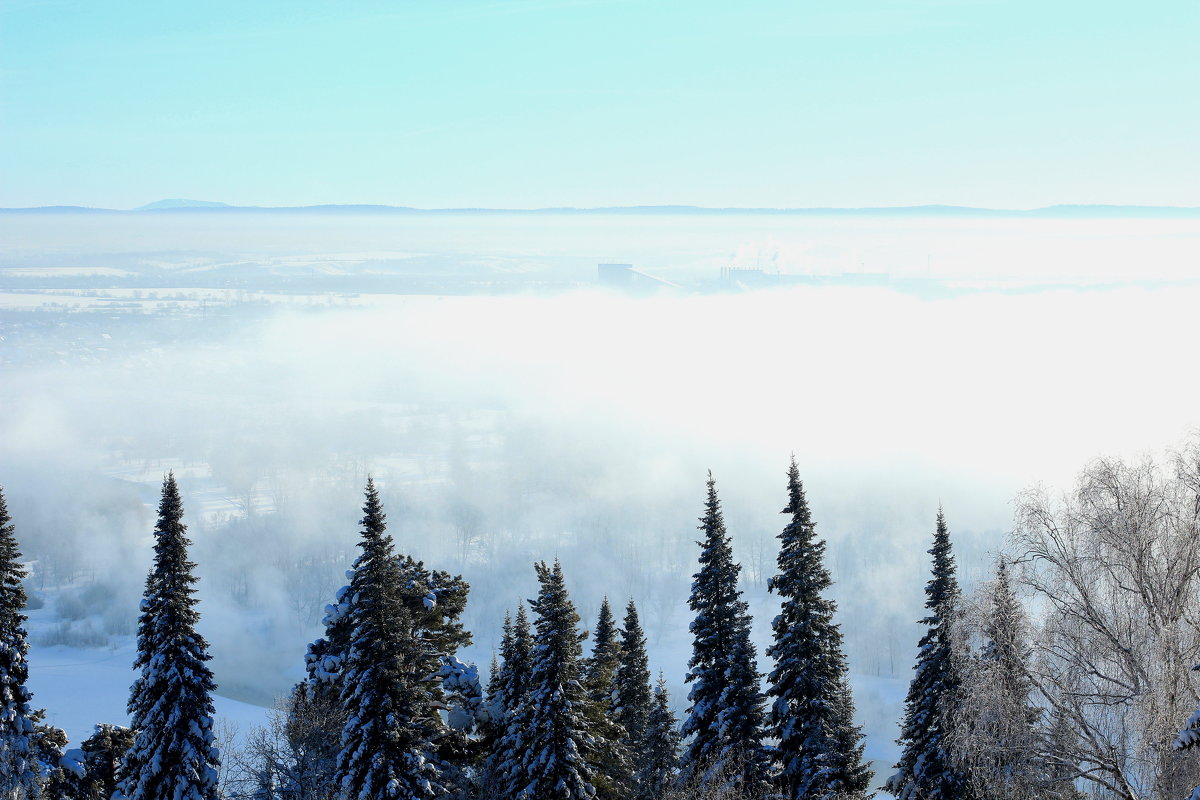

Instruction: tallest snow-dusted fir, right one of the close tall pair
[767,458,872,800]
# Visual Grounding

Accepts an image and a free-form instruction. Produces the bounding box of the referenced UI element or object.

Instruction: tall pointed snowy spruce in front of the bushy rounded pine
[335,479,443,800]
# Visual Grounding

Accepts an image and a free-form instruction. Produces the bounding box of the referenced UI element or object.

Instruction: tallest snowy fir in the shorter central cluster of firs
[499,561,595,800]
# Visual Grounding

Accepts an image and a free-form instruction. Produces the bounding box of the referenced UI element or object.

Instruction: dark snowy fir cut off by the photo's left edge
[0,491,42,800]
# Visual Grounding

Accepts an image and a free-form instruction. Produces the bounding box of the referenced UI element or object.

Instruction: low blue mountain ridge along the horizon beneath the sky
[0,199,1200,219]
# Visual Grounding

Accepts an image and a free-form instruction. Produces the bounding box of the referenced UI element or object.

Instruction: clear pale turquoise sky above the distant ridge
[0,0,1200,207]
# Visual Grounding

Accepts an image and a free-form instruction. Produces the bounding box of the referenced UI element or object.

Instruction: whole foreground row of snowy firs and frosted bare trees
[0,447,1200,800]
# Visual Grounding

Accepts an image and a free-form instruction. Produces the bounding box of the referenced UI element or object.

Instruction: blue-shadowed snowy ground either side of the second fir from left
[28,592,269,746]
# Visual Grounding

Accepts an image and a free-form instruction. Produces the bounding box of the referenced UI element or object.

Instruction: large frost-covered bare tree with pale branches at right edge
[1014,439,1200,800]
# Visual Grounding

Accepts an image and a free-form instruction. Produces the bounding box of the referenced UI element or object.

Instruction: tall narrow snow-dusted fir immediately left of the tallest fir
[680,473,770,795]
